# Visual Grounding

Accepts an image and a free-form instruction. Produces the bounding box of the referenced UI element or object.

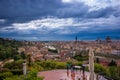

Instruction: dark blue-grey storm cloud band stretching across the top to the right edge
[0,0,120,18]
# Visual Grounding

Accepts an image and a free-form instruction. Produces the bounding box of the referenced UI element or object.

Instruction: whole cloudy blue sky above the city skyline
[0,0,120,41]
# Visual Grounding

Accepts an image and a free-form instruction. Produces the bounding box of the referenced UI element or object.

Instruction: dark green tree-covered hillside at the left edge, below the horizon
[0,38,22,60]
